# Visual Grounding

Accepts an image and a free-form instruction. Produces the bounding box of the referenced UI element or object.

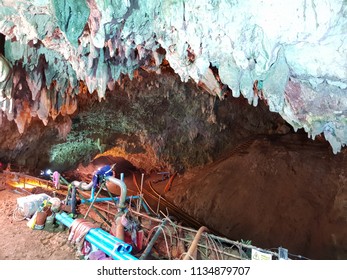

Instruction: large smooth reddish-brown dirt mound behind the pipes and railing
[167,135,347,259]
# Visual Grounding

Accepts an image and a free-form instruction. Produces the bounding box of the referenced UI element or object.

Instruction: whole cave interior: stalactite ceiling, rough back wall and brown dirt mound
[0,0,347,259]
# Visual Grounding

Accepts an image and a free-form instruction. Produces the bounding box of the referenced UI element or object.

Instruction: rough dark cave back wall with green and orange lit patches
[50,66,290,172]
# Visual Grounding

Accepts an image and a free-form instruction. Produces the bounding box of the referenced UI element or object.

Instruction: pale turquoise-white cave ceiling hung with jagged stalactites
[0,0,347,158]
